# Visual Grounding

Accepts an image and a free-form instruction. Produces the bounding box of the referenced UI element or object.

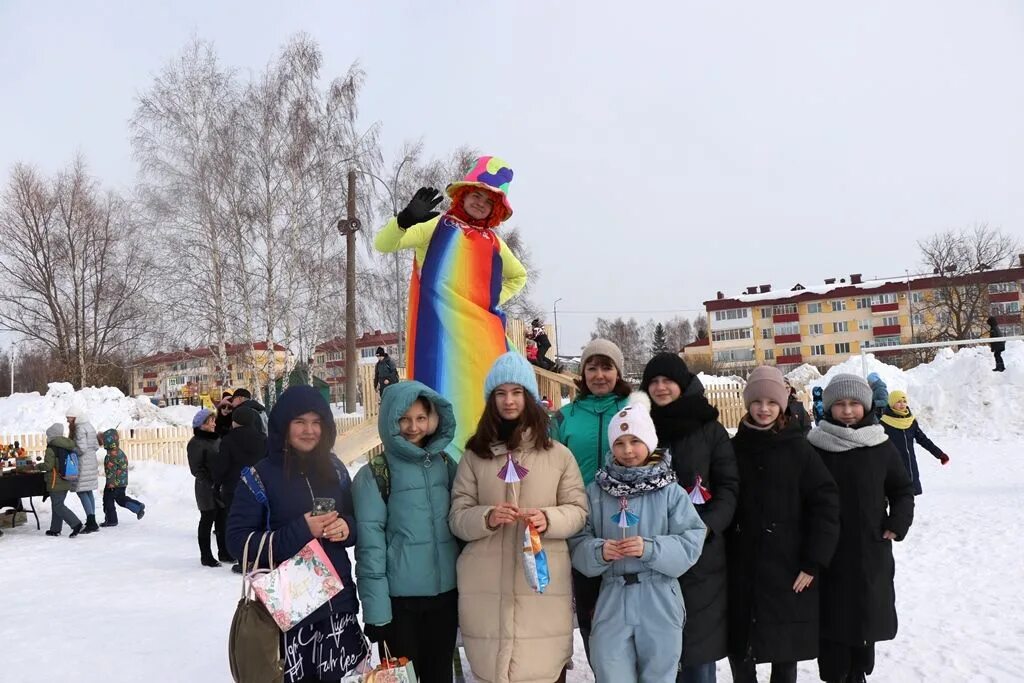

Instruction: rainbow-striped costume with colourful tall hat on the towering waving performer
[374,157,526,457]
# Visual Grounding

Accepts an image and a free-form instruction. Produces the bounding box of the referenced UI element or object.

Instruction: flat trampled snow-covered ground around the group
[0,430,1024,683]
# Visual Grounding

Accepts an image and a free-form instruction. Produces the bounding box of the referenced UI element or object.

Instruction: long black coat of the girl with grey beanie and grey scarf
[817,436,913,645]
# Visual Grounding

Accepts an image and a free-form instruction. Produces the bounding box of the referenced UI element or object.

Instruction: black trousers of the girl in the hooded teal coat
[377,591,459,683]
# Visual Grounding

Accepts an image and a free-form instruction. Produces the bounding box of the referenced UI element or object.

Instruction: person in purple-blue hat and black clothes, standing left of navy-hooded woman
[185,409,234,567]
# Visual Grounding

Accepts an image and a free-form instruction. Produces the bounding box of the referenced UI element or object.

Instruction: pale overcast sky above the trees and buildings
[0,0,1024,352]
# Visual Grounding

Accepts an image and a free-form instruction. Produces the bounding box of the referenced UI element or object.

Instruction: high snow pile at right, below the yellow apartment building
[811,341,1024,440]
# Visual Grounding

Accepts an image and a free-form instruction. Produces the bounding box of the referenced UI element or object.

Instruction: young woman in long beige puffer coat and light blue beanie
[449,351,587,683]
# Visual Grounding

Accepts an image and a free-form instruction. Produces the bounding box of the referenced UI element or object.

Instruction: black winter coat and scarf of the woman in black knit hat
[651,377,739,667]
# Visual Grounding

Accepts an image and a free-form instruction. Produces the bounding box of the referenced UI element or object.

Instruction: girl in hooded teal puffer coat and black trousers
[352,382,459,683]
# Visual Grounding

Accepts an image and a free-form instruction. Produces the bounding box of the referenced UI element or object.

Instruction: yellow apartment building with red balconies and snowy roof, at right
[705,255,1024,372]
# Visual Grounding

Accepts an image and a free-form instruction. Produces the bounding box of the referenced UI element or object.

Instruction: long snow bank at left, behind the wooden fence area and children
[0,382,199,433]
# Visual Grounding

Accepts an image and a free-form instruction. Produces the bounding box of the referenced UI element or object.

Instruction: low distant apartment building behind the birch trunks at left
[131,342,289,403]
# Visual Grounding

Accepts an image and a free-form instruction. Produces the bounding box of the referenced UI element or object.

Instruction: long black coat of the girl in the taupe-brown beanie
[726,420,839,661]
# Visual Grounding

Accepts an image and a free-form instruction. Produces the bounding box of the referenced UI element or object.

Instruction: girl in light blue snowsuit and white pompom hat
[569,394,707,683]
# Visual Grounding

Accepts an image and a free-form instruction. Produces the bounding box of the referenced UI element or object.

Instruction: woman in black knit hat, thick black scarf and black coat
[640,353,739,683]
